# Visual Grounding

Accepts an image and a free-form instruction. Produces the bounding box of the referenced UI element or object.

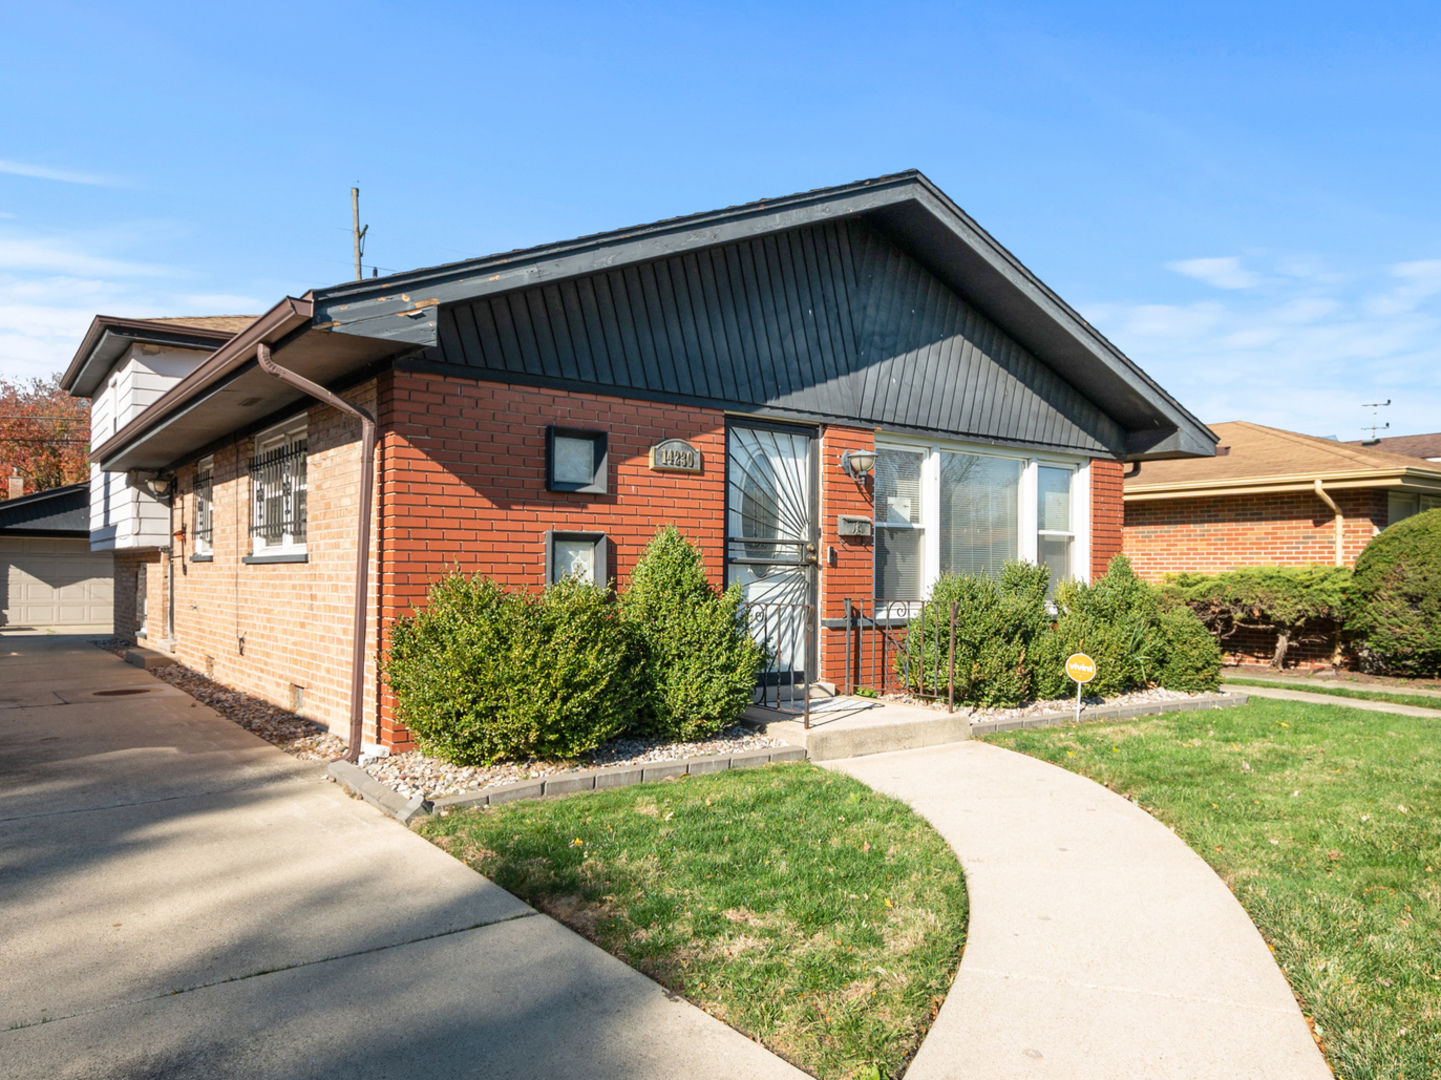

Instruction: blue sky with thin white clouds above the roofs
[0,0,1441,438]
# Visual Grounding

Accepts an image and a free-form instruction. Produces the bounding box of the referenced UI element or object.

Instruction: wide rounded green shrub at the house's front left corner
[385,574,644,764]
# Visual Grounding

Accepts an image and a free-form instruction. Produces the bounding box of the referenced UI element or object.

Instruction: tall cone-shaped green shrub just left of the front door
[621,525,765,740]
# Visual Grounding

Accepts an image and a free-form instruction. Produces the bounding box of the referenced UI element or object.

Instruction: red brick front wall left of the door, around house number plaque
[380,372,725,748]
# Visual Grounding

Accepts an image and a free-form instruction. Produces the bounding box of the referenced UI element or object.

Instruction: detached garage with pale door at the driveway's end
[0,484,115,633]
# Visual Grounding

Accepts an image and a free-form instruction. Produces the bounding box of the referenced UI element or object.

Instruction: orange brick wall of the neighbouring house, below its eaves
[1125,489,1386,580]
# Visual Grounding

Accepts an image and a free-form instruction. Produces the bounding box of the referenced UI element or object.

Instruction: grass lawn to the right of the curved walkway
[986,699,1441,1080]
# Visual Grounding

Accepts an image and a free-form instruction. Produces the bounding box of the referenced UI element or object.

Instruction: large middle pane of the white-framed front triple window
[940,451,1025,577]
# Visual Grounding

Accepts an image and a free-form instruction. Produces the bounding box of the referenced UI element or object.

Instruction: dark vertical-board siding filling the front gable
[435,219,1121,451]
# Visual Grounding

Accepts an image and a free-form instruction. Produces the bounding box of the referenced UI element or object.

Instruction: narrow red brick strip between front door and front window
[818,427,876,683]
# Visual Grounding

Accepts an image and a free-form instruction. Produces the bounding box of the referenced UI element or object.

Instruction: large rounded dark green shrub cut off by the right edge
[1346,509,1441,676]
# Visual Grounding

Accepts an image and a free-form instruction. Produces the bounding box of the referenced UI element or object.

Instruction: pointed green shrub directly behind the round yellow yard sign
[1036,555,1164,698]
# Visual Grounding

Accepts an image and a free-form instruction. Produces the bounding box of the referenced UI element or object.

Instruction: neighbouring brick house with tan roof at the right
[1124,421,1441,580]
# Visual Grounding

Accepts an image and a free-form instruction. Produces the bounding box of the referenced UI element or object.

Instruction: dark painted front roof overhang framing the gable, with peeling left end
[314,170,1218,461]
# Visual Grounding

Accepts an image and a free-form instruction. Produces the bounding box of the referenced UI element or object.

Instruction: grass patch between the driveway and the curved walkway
[422,764,965,1079]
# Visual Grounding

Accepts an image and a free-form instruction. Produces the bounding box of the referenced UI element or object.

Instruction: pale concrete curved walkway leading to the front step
[827,743,1331,1080]
